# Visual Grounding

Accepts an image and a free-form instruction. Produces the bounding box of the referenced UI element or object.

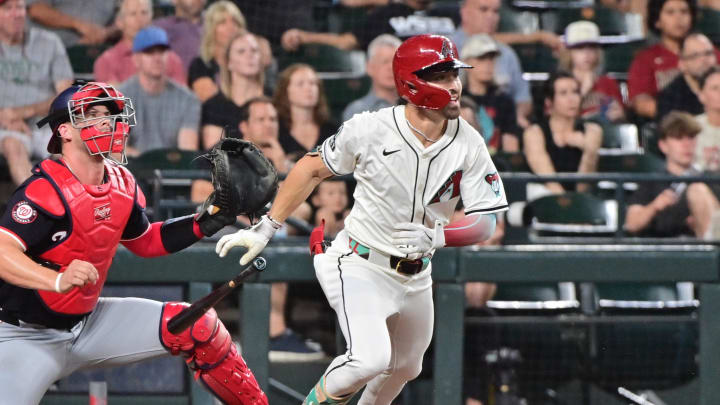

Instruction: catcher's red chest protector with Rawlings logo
[37,160,135,315]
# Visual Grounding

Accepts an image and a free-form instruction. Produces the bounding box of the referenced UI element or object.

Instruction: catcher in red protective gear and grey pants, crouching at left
[0,82,267,405]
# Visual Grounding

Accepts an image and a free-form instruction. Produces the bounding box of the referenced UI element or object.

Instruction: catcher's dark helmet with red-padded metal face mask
[37,81,135,164]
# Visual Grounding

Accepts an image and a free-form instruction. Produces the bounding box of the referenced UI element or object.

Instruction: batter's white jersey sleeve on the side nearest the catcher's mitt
[320,116,362,176]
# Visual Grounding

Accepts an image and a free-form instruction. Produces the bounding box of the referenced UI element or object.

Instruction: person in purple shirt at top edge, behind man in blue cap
[153,0,207,72]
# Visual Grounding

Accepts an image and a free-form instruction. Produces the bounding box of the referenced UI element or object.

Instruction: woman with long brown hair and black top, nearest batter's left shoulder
[273,63,338,161]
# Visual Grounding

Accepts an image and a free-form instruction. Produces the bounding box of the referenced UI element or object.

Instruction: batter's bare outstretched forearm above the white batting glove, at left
[268,156,330,222]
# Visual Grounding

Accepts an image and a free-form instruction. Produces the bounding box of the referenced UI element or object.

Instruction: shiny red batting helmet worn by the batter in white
[393,35,472,110]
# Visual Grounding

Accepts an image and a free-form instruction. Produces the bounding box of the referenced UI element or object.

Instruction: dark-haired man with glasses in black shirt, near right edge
[657,33,718,121]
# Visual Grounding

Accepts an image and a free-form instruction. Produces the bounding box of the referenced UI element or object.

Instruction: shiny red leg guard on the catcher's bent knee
[160,302,268,405]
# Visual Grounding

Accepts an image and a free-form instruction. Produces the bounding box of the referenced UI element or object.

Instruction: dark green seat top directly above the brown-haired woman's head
[277,44,365,73]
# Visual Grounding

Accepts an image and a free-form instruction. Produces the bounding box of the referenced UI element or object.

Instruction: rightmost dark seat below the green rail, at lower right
[590,283,699,391]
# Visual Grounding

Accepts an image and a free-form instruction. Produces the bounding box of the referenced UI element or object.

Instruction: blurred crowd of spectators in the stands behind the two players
[0,0,720,403]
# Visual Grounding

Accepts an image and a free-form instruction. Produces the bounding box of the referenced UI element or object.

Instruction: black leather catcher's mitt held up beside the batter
[196,138,278,236]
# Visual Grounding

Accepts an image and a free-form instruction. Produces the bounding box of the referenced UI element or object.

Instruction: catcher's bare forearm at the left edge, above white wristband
[0,244,58,291]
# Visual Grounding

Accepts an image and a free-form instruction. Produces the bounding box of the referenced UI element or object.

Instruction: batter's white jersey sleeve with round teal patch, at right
[460,139,508,215]
